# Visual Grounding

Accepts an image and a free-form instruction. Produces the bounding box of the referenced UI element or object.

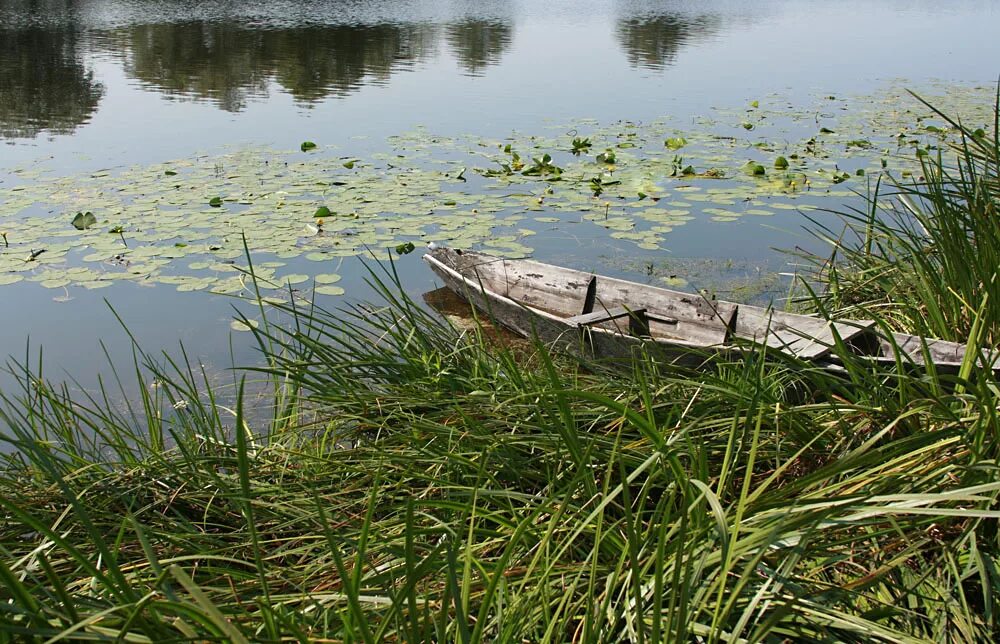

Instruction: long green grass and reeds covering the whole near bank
[0,102,1000,642]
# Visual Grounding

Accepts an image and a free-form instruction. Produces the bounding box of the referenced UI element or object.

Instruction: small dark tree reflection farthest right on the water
[615,14,722,69]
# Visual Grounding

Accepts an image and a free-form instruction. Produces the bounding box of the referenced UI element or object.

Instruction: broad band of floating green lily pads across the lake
[0,82,993,295]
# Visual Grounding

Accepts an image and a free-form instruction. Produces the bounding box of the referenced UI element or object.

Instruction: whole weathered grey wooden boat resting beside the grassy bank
[424,248,998,372]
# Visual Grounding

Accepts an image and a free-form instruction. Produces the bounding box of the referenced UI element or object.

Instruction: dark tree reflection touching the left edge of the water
[0,26,104,139]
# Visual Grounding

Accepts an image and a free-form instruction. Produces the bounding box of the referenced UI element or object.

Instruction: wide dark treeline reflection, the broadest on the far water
[105,22,435,112]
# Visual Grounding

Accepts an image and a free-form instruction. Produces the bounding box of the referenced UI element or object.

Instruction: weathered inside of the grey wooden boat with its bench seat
[432,249,992,366]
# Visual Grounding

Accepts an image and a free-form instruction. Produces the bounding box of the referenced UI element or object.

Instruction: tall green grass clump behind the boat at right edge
[792,88,1000,346]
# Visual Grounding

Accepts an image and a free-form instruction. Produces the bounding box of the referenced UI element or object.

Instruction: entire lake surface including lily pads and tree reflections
[0,0,1000,386]
